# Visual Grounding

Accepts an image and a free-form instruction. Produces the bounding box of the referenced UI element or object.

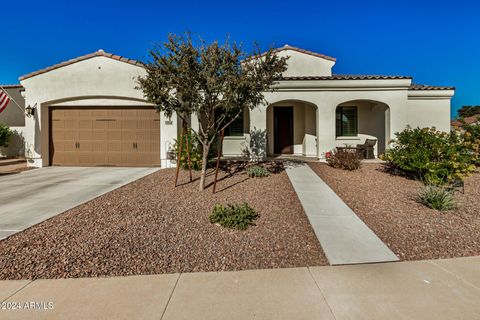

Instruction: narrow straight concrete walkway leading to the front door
[287,164,398,265]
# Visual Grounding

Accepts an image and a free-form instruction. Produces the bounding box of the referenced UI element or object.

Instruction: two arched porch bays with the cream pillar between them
[266,99,390,160]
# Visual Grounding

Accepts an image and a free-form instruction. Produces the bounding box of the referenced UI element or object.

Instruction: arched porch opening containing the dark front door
[266,100,318,157]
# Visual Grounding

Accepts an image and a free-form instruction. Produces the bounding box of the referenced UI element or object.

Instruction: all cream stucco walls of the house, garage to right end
[17,50,453,167]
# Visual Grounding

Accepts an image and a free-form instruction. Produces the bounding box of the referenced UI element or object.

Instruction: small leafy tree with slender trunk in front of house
[138,33,287,190]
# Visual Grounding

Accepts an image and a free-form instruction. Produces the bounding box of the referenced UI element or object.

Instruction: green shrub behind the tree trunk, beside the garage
[173,129,217,171]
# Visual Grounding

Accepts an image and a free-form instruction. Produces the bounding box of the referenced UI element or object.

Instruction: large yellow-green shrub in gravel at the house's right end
[383,128,478,185]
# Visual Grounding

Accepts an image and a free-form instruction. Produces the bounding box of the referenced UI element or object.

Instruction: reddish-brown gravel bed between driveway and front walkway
[0,165,327,280]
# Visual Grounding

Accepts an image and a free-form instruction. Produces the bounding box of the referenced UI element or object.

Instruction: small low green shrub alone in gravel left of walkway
[209,203,259,230]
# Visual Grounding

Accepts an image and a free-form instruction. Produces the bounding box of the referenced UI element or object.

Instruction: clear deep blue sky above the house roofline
[0,0,480,114]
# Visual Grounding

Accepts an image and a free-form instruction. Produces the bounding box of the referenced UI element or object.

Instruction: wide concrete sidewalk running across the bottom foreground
[0,257,480,320]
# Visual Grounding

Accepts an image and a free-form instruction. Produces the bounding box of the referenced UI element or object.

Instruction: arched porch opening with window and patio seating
[335,100,390,157]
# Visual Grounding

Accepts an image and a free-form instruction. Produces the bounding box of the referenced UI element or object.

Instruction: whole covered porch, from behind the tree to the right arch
[216,99,392,160]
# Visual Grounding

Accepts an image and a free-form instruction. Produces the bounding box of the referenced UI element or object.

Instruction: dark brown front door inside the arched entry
[273,107,293,154]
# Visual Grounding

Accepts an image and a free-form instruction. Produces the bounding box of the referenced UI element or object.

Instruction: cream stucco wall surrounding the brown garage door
[21,56,177,167]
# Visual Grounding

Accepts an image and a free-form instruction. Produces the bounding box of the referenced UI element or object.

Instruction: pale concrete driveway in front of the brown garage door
[0,167,159,239]
